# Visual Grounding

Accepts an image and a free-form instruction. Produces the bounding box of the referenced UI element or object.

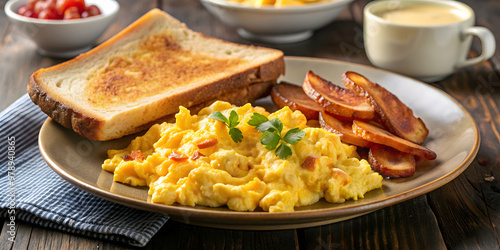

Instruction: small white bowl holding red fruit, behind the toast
[5,0,120,58]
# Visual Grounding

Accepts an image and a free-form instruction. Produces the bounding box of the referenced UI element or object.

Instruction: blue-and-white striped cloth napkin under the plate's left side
[0,94,168,246]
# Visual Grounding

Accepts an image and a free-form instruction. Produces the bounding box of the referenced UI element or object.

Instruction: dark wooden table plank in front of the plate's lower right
[299,196,445,249]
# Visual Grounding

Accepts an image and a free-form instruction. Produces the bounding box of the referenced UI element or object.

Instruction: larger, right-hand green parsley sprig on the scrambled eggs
[248,113,306,160]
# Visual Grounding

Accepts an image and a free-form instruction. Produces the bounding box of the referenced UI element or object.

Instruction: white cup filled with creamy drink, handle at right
[363,0,495,81]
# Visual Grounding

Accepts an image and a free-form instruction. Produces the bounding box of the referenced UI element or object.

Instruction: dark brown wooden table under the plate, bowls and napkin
[0,0,500,249]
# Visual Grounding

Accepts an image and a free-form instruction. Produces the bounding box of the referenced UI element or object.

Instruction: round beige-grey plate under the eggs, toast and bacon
[39,57,480,230]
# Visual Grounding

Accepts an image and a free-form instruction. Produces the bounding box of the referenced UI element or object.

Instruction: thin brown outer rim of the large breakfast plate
[38,56,481,230]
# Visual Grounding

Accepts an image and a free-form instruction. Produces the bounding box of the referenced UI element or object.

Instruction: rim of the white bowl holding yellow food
[200,0,354,13]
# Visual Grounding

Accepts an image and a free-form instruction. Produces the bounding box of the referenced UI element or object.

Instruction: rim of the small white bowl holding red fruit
[4,0,120,25]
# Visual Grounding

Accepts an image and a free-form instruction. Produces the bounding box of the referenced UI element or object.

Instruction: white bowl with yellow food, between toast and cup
[200,0,353,43]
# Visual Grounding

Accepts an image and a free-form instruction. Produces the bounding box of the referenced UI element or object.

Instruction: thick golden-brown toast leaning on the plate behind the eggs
[28,9,285,141]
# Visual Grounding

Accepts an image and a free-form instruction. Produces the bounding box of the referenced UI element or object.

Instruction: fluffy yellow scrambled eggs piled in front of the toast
[102,102,382,212]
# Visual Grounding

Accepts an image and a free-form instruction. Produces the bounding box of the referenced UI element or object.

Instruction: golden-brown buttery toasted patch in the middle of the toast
[85,34,244,108]
